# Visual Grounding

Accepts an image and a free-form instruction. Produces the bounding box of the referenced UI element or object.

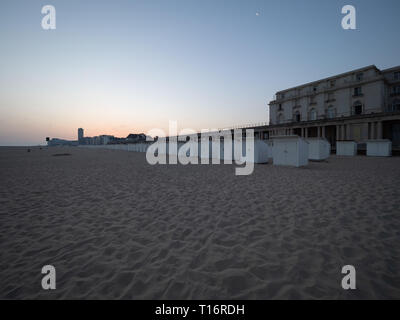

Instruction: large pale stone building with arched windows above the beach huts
[262,65,400,146]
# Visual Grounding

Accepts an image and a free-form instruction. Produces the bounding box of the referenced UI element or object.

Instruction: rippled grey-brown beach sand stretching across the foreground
[0,148,400,299]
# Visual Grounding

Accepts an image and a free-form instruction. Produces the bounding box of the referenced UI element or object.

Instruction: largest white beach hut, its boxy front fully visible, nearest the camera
[272,136,308,167]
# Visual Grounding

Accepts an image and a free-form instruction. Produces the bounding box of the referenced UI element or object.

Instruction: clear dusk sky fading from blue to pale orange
[0,0,400,145]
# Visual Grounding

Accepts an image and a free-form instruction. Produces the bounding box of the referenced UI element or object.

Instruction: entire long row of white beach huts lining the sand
[79,136,392,167]
